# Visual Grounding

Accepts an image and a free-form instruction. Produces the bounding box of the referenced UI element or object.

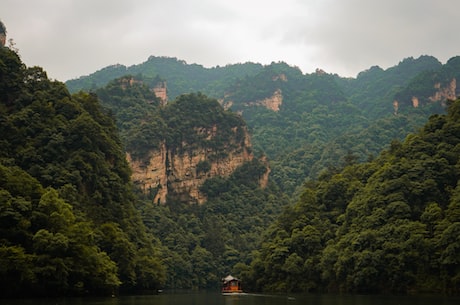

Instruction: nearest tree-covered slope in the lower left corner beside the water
[0,166,121,296]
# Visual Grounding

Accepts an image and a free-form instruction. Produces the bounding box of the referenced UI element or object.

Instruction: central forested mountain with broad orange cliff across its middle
[95,76,288,289]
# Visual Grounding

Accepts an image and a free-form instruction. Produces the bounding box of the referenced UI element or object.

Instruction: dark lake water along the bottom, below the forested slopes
[0,293,460,305]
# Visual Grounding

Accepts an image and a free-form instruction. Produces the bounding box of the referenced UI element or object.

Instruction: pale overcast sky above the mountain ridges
[0,0,460,81]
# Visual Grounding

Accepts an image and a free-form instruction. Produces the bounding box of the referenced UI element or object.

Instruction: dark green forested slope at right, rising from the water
[246,100,460,294]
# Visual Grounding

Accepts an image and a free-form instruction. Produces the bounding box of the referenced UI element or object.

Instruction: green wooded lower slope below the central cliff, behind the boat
[141,161,288,289]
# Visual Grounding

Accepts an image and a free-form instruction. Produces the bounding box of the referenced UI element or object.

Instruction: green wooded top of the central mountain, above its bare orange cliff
[95,76,250,161]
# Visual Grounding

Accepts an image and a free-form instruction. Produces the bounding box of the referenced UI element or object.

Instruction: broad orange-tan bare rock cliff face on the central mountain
[127,126,260,204]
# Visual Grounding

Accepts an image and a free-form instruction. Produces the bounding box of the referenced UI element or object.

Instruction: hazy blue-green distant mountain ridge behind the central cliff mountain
[67,56,458,194]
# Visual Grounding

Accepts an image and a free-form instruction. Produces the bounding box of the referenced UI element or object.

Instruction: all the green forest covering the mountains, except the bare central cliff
[0,29,460,296]
